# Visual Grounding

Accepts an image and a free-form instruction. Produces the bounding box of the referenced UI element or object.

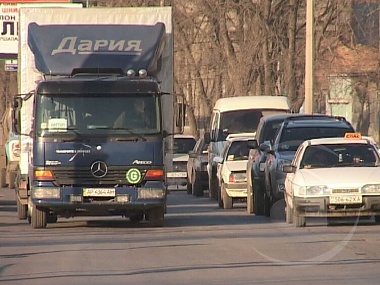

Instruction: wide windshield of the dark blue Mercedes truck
[35,94,161,136]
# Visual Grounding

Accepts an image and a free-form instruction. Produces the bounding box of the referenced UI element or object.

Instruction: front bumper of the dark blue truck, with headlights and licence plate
[31,186,166,215]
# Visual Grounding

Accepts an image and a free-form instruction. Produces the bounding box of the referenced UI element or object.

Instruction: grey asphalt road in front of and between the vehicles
[0,186,380,285]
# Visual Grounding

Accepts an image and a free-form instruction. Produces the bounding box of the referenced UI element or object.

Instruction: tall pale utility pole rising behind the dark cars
[304,0,314,114]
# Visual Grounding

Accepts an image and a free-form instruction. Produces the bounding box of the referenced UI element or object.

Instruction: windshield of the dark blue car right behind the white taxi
[277,127,350,151]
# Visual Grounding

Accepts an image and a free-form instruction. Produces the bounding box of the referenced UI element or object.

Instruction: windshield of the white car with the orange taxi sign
[300,144,379,168]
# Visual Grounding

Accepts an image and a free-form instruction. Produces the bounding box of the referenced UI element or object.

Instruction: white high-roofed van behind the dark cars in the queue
[204,96,290,199]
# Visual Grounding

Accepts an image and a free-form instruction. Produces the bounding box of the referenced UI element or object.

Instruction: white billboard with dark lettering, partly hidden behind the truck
[0,0,83,59]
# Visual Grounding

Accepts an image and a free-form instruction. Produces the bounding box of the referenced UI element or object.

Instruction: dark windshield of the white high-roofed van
[220,109,288,134]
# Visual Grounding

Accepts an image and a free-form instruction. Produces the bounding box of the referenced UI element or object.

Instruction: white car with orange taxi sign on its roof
[284,133,380,227]
